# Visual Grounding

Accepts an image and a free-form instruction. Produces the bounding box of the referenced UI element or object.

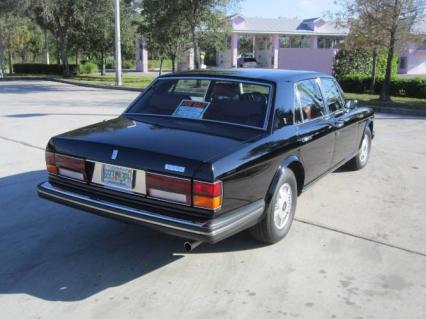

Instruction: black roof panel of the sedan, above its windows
[160,68,331,82]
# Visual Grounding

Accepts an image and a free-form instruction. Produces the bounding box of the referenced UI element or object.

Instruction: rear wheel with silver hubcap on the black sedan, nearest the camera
[251,169,297,244]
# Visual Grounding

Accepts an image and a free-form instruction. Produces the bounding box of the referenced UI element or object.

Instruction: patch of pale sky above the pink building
[237,0,339,18]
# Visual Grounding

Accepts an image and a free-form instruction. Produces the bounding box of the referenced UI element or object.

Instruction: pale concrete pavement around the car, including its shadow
[0,81,426,319]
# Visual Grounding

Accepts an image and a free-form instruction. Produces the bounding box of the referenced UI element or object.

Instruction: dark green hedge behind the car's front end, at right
[339,75,426,99]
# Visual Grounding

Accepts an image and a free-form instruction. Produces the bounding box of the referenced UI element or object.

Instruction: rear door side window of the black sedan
[296,79,326,121]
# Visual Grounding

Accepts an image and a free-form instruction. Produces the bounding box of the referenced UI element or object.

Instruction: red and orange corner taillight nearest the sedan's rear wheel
[192,181,222,210]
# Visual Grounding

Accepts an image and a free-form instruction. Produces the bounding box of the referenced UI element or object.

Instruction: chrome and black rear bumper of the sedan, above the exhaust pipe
[37,182,265,243]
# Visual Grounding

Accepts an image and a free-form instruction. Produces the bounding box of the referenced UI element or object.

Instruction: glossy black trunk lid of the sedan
[48,116,264,177]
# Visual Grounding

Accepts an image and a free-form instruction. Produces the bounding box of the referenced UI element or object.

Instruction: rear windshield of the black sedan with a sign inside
[127,78,271,128]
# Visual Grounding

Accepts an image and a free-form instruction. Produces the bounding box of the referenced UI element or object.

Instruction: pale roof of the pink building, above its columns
[231,15,348,36]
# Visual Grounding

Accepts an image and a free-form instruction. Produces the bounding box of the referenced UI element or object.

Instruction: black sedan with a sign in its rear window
[38,69,374,249]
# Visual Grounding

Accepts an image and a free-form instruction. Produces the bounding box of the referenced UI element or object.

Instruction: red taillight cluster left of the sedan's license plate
[46,151,86,181]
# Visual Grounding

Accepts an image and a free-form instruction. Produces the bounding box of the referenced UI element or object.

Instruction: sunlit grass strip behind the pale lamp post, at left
[68,73,155,89]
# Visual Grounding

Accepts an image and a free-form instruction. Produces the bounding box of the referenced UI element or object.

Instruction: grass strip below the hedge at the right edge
[345,93,426,110]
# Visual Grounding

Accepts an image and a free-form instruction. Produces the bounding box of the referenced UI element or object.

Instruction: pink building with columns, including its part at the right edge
[216,15,426,74]
